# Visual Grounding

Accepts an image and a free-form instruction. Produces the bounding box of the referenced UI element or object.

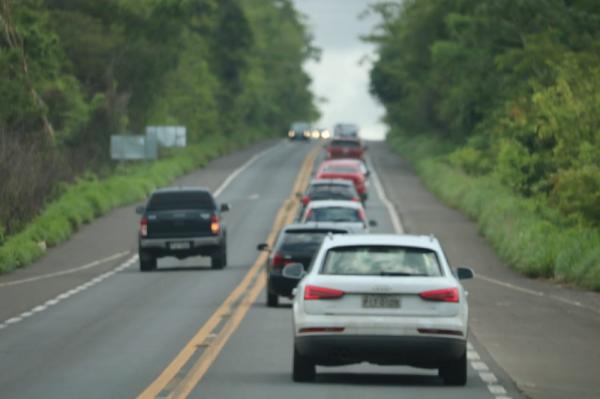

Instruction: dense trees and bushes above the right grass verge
[372,0,600,224]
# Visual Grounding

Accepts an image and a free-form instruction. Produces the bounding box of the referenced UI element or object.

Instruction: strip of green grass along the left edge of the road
[0,135,258,273]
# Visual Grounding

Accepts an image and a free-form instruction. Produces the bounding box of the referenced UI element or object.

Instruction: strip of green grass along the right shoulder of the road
[388,135,600,292]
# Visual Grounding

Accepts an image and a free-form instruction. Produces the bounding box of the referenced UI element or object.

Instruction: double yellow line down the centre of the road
[138,147,319,399]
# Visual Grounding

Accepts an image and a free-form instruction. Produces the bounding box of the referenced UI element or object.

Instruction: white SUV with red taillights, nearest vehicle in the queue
[283,234,473,385]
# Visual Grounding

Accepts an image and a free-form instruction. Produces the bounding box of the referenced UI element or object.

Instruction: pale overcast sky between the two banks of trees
[294,0,386,139]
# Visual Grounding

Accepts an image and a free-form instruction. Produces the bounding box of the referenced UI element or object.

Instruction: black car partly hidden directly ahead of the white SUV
[258,222,349,307]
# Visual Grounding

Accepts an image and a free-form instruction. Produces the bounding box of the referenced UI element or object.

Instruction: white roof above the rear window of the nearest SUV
[323,233,441,251]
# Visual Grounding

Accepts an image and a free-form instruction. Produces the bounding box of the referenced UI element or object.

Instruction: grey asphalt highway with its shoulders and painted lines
[0,141,600,399]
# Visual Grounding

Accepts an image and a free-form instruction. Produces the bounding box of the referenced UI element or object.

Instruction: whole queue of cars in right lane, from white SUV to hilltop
[258,124,473,385]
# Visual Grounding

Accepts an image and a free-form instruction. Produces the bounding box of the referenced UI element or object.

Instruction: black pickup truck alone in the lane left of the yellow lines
[136,187,229,271]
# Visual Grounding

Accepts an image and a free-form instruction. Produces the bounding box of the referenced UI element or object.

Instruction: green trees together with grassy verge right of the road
[370,0,600,291]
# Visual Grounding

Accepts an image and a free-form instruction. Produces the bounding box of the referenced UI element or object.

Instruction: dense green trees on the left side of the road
[0,0,317,238]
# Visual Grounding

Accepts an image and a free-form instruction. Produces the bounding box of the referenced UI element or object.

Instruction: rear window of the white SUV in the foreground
[321,245,442,277]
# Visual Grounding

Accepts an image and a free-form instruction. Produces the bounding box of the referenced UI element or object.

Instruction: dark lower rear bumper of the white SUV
[294,334,466,368]
